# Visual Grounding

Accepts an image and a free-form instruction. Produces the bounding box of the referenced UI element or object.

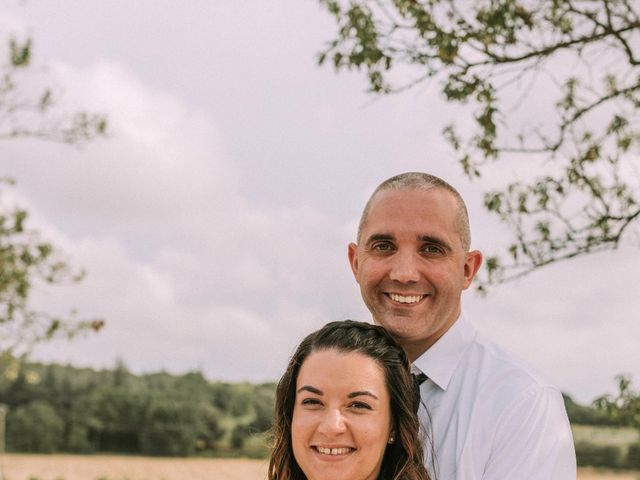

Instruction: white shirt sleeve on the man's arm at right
[481,385,577,480]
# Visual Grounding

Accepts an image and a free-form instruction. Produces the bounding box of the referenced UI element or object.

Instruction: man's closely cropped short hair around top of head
[358,172,471,251]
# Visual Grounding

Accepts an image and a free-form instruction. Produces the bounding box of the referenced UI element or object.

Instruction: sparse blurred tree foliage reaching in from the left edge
[0,38,107,354]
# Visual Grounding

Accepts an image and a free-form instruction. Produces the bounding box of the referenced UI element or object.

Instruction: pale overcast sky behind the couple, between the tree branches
[0,0,640,402]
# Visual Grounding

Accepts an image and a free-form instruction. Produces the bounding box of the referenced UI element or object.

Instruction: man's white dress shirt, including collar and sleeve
[413,315,576,480]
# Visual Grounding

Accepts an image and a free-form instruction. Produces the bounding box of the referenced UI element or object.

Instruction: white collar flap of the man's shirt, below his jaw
[413,314,477,390]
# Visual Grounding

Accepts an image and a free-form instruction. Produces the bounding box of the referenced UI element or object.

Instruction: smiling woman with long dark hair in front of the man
[268,320,429,480]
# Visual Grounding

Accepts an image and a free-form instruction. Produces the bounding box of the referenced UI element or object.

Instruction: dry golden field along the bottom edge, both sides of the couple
[0,455,640,480]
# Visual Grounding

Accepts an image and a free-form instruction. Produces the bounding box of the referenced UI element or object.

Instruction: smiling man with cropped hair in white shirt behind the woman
[349,173,576,480]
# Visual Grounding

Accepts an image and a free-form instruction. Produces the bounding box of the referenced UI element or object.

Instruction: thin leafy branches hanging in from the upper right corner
[319,0,640,288]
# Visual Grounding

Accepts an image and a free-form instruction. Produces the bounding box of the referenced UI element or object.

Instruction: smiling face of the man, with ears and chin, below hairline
[349,188,482,360]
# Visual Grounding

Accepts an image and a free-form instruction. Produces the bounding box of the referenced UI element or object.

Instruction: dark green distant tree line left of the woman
[0,361,275,456]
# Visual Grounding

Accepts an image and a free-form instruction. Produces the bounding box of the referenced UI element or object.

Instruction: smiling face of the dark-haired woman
[291,349,391,480]
